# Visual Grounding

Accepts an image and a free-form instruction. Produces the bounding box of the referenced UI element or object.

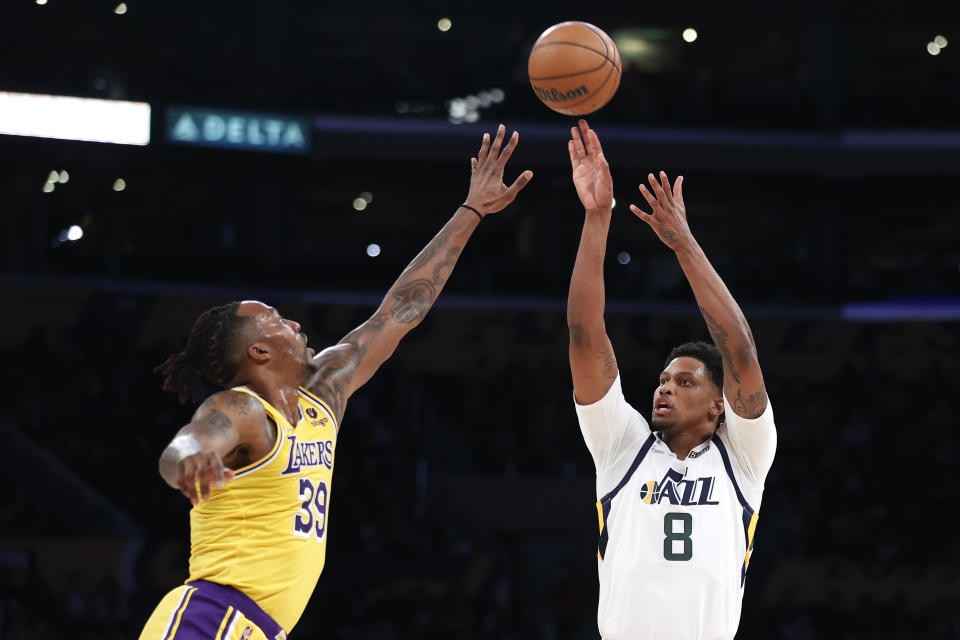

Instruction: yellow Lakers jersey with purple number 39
[188,387,338,633]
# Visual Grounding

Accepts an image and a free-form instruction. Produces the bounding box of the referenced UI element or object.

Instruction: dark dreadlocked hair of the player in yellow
[154,302,249,404]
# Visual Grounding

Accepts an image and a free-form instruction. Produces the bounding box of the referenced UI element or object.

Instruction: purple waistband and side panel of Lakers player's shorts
[184,580,286,640]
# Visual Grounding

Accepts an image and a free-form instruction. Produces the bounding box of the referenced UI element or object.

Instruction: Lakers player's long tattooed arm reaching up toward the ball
[307,125,533,422]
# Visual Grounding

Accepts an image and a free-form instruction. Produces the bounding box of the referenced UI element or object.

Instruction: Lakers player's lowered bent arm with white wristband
[160,390,266,504]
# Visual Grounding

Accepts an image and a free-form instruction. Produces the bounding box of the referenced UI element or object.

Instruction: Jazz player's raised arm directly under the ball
[567,120,617,404]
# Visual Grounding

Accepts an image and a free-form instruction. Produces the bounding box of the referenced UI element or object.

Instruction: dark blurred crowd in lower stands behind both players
[0,294,960,640]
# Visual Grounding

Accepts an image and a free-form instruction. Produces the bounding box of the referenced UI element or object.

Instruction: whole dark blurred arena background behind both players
[0,0,960,640]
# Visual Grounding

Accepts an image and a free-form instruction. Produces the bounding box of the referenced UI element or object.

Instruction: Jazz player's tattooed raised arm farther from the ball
[630,171,767,418]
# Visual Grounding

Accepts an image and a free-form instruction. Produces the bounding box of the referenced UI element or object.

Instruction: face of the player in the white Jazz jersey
[651,356,721,431]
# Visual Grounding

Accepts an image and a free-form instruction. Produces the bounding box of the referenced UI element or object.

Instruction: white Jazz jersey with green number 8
[576,375,777,640]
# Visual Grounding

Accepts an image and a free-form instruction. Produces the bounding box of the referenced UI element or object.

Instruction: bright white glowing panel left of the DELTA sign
[0,91,150,146]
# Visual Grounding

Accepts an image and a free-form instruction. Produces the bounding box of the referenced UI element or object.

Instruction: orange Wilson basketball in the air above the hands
[527,22,622,116]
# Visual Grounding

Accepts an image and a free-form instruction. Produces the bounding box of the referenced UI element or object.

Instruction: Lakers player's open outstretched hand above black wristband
[464,124,533,216]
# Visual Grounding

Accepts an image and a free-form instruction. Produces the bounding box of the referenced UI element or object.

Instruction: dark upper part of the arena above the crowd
[0,0,960,305]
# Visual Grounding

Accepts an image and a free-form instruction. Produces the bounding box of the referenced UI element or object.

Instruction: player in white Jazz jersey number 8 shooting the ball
[567,120,776,640]
